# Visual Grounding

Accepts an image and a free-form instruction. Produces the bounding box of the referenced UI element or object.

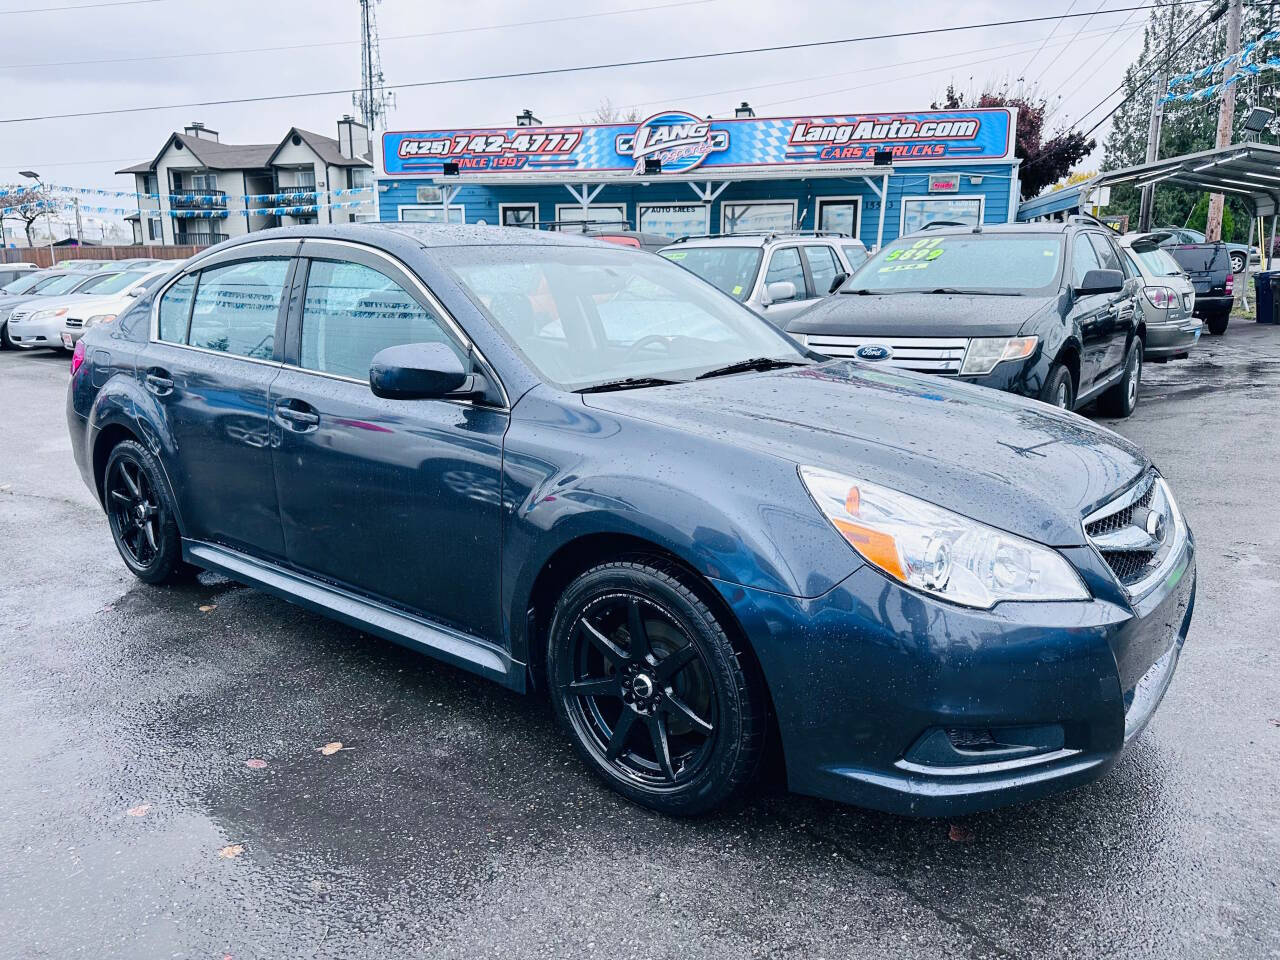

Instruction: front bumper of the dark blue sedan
[718,534,1196,817]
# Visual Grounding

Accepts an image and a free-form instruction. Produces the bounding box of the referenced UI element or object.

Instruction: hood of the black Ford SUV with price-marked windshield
[787,293,1057,337]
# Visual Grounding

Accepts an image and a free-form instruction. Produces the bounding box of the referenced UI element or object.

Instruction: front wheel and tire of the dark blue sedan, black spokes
[547,558,765,817]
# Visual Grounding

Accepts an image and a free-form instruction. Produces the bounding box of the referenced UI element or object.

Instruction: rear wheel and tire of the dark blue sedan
[102,440,196,584]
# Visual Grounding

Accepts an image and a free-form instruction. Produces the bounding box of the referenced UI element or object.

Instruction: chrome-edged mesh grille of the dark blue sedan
[1084,474,1181,593]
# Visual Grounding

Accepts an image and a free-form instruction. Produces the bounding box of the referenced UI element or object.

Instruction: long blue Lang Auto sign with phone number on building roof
[383,108,1015,179]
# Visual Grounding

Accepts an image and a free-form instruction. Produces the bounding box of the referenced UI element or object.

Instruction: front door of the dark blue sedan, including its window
[271,241,508,640]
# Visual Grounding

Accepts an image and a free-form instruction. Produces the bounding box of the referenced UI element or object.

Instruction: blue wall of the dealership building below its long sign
[379,163,1016,247]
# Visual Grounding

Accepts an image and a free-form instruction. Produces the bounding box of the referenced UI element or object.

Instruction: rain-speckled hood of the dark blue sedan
[584,361,1149,547]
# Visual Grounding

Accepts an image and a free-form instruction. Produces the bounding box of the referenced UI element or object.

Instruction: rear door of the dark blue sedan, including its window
[137,241,298,558]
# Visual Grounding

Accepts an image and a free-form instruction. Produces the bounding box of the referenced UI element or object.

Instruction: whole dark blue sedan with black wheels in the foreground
[68,225,1196,815]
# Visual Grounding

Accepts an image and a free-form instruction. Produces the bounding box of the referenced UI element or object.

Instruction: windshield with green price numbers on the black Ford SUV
[840,233,1062,294]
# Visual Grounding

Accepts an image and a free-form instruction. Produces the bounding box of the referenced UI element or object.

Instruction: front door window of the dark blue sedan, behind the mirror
[300,260,467,380]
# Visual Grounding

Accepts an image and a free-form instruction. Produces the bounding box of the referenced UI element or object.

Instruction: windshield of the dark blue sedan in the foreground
[435,246,808,390]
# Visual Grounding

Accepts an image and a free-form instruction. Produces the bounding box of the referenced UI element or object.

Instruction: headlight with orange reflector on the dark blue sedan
[800,466,1089,609]
